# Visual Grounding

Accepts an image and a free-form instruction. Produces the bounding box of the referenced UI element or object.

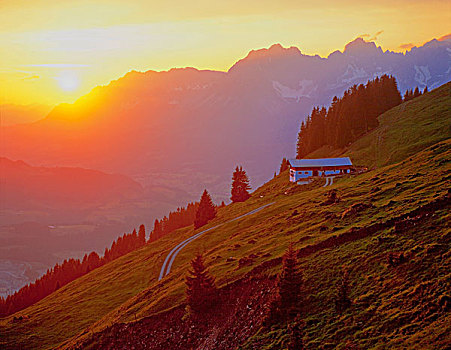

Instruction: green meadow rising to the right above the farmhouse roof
[308,82,451,167]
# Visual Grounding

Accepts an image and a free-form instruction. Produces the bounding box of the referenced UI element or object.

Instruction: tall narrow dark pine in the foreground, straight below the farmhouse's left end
[278,243,302,316]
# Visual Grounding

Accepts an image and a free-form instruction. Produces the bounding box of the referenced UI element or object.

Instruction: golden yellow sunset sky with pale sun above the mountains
[0,0,451,105]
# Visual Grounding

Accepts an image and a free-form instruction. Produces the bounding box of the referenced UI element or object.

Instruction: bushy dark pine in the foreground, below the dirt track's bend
[185,254,217,315]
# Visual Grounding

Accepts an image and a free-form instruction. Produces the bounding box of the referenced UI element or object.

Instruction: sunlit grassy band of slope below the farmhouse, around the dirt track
[0,85,451,348]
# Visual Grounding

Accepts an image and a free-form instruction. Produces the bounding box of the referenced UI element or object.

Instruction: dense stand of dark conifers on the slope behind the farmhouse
[296,75,427,159]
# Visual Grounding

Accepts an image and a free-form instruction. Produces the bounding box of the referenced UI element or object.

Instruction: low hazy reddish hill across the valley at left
[0,158,143,210]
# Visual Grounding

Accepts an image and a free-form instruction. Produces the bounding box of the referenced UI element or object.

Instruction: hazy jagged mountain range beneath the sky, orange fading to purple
[1,37,451,199]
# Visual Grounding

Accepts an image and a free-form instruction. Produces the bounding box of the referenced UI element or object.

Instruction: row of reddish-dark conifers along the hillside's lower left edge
[0,225,146,317]
